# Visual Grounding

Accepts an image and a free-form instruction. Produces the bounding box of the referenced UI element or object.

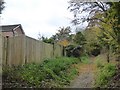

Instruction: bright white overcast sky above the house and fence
[1,0,87,39]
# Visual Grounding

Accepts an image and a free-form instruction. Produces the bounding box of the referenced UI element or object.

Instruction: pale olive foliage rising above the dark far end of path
[84,26,101,56]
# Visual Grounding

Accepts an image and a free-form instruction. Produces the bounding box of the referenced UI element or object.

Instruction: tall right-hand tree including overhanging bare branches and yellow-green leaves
[70,0,120,62]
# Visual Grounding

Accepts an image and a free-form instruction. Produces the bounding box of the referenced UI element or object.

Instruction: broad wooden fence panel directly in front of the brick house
[6,36,25,66]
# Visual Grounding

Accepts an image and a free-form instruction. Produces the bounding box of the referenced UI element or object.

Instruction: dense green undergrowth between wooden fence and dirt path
[3,57,80,88]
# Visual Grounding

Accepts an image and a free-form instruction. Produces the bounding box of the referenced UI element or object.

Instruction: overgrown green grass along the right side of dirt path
[95,55,116,87]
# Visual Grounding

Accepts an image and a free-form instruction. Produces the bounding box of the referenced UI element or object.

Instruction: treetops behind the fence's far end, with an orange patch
[38,26,71,46]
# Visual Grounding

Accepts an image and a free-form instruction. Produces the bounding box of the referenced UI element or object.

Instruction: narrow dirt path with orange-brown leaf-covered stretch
[68,58,96,88]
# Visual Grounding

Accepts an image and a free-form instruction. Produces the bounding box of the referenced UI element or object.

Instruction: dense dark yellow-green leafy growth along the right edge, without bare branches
[97,2,120,62]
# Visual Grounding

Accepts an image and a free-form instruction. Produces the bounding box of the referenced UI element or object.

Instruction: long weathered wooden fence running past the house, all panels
[0,35,63,66]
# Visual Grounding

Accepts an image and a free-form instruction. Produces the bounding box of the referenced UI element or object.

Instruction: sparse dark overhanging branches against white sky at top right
[68,0,111,25]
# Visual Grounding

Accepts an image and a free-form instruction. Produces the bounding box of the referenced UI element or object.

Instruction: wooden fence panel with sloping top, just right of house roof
[25,37,43,63]
